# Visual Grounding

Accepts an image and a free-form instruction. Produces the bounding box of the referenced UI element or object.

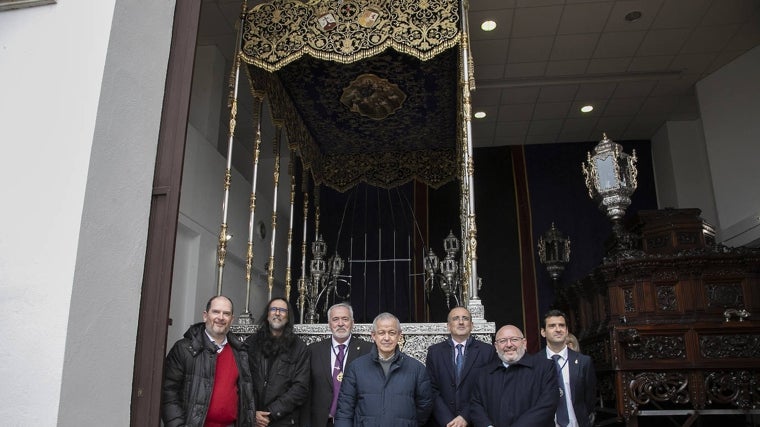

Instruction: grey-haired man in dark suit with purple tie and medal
[307,303,372,427]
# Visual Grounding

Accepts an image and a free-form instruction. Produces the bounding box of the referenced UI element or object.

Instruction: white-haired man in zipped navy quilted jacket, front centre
[335,313,433,427]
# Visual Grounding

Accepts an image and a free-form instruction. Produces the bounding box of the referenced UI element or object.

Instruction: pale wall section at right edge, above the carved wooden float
[697,47,760,246]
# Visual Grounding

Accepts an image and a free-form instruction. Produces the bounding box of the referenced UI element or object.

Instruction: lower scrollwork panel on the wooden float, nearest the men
[626,372,690,405]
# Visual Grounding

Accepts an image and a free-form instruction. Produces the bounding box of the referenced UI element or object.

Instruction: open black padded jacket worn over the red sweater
[161,322,255,427]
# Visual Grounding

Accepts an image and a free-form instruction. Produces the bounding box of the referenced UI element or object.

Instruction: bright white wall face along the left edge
[0,0,116,426]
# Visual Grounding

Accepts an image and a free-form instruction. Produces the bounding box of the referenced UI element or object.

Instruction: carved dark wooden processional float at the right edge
[561,209,760,424]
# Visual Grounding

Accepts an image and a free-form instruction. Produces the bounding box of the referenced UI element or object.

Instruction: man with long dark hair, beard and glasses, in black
[245,298,309,427]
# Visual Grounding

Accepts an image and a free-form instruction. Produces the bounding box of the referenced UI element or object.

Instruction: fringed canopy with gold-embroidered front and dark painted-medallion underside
[241,0,462,191]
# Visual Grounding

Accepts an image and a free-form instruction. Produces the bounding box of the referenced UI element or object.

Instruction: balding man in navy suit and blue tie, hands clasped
[425,307,497,427]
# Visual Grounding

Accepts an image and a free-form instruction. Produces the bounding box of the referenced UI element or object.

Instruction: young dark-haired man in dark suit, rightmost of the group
[541,310,596,427]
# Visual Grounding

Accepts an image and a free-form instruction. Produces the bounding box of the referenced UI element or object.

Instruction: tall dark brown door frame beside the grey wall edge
[130,0,201,427]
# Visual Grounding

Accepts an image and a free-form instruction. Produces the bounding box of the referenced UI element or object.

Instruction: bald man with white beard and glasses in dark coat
[470,325,559,427]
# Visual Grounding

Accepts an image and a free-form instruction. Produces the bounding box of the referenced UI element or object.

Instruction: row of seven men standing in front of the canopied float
[161,296,596,427]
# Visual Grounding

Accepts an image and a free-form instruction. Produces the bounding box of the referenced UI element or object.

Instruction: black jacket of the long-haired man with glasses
[246,332,309,427]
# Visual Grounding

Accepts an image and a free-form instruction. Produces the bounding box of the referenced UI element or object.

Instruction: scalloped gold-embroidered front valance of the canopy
[242,0,460,72]
